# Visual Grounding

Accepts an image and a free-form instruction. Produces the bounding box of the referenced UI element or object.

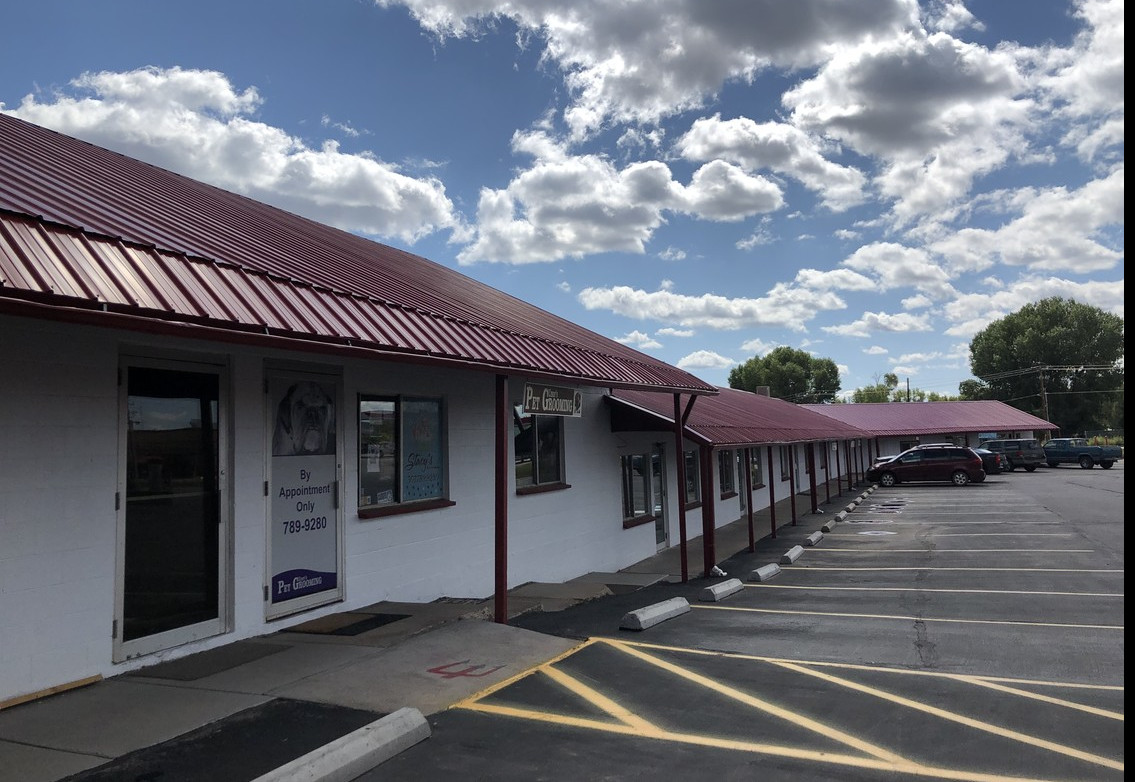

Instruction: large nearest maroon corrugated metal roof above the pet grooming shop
[0,115,716,394]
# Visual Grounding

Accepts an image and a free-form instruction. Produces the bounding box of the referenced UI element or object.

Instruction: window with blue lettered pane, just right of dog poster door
[359,396,446,510]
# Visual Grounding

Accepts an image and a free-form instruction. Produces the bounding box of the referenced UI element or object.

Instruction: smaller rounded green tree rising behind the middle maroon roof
[729,345,840,403]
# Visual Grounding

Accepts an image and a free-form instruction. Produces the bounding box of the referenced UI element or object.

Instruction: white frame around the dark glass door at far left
[111,352,233,663]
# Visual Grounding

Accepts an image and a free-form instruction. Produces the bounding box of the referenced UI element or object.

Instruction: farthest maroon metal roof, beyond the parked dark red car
[800,400,1058,437]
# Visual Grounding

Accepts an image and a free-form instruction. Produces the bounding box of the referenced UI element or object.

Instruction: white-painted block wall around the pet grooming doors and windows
[0,317,681,701]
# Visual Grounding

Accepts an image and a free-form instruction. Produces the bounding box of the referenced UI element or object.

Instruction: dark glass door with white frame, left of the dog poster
[116,364,222,659]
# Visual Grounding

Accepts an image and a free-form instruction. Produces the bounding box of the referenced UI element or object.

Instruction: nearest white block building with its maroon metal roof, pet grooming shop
[0,115,867,706]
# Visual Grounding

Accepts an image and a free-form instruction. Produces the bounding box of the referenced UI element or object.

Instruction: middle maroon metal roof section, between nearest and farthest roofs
[607,388,869,447]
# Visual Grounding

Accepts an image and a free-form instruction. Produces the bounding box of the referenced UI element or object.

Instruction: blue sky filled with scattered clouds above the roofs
[0,0,1124,394]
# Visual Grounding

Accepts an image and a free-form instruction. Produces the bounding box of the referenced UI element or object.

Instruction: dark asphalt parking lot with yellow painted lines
[376,470,1124,781]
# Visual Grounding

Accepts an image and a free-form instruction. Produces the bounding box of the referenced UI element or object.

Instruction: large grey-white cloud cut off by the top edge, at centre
[377,0,917,138]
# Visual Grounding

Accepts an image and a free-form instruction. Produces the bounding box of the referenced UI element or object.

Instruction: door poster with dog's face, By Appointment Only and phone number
[268,377,339,613]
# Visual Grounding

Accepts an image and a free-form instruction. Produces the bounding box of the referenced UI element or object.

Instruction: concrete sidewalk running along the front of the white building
[0,489,848,782]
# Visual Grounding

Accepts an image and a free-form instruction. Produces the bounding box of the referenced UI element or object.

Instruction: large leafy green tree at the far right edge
[959,297,1124,435]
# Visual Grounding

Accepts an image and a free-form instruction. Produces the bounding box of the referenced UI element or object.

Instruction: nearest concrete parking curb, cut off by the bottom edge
[254,706,430,782]
